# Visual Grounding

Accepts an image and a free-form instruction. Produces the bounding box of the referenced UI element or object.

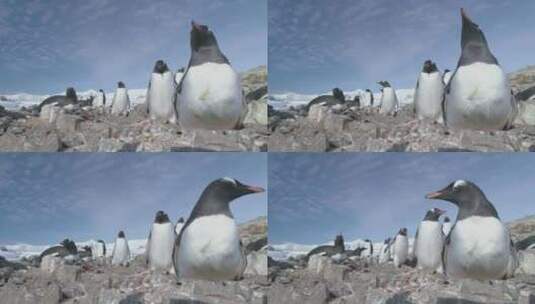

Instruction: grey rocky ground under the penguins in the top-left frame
[0,66,267,152]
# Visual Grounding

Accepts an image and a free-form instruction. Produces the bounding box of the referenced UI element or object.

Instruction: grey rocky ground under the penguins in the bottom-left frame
[0,218,268,304]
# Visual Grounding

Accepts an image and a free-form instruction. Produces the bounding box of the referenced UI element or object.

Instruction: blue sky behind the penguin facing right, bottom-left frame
[0,153,267,244]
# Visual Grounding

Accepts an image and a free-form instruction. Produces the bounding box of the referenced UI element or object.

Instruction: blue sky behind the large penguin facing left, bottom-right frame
[268,153,535,244]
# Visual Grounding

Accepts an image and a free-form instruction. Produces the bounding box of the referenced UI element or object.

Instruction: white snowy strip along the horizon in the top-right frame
[268,89,414,110]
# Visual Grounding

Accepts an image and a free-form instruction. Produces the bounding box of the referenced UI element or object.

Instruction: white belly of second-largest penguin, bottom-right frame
[416,221,444,271]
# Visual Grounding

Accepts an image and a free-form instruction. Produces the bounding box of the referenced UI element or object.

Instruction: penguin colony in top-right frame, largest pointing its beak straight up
[307,9,531,131]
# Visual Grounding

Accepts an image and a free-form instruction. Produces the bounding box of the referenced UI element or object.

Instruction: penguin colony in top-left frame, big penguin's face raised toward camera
[39,21,247,130]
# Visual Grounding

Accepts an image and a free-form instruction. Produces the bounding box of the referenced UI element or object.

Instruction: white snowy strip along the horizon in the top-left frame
[0,89,147,111]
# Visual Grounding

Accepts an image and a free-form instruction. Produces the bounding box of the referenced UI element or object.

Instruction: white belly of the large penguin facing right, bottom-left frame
[178,215,244,280]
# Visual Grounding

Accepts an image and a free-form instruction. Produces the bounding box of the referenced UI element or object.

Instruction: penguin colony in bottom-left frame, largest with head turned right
[36,177,264,281]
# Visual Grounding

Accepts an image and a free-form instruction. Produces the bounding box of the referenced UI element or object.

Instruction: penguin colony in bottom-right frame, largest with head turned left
[307,180,524,280]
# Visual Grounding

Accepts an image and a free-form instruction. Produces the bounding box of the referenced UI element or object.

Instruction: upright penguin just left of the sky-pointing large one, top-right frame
[414,60,444,122]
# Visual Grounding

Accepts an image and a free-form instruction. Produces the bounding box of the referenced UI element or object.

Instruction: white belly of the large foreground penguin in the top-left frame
[178,62,244,130]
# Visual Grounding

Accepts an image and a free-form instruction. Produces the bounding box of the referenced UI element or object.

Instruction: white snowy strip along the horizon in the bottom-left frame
[0,239,147,261]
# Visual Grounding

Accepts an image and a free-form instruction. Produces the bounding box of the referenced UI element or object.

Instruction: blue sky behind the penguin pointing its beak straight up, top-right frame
[268,0,535,93]
